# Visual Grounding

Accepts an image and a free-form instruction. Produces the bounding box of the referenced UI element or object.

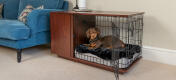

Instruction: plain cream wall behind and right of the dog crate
[70,0,176,50]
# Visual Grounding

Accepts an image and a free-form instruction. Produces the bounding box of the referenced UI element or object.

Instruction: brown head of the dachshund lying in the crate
[86,27,100,40]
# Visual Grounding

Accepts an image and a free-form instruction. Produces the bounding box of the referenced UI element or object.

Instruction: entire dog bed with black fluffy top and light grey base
[75,44,141,68]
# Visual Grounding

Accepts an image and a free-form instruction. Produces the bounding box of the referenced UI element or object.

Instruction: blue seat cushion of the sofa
[0,19,30,40]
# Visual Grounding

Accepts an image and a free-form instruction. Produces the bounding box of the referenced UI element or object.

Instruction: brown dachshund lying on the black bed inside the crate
[86,27,125,49]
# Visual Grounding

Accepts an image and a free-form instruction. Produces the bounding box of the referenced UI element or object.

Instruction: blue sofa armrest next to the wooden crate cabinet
[26,9,64,34]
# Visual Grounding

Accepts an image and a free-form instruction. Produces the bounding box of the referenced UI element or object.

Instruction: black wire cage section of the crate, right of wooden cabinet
[73,12,143,72]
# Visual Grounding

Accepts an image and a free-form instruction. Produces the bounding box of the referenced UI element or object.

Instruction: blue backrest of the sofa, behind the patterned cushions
[0,0,64,19]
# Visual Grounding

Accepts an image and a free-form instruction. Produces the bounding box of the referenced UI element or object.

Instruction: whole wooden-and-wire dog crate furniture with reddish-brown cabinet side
[50,11,144,79]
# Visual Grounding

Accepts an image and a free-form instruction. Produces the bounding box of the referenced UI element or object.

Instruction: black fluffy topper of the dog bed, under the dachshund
[76,44,141,60]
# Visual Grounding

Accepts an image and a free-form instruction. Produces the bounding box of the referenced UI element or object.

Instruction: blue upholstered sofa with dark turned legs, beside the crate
[0,0,68,62]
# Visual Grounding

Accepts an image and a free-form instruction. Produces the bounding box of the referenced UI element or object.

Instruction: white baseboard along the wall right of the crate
[143,46,176,65]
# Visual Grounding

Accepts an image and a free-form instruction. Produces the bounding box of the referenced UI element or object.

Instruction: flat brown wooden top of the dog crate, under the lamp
[54,11,144,17]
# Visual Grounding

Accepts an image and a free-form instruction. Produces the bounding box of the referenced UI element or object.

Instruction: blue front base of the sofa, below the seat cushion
[0,32,50,49]
